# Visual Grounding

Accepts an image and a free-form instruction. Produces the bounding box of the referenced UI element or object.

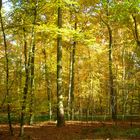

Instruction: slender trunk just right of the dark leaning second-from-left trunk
[29,0,38,124]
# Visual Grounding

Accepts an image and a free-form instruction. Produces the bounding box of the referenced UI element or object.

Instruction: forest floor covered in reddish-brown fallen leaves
[0,121,140,140]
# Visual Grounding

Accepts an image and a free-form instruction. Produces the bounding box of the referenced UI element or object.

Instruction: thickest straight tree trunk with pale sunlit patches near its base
[57,0,65,127]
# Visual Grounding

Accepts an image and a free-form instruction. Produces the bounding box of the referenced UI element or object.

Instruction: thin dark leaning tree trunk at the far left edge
[0,0,13,135]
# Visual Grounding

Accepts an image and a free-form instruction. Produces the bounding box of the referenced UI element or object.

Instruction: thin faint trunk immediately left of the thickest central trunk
[43,48,52,120]
